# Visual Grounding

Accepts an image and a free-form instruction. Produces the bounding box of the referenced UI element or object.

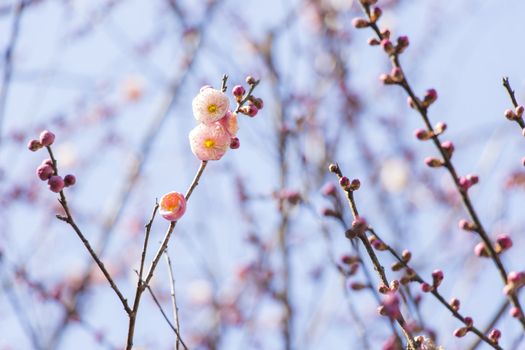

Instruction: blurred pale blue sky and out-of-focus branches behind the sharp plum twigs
[0,0,525,350]
